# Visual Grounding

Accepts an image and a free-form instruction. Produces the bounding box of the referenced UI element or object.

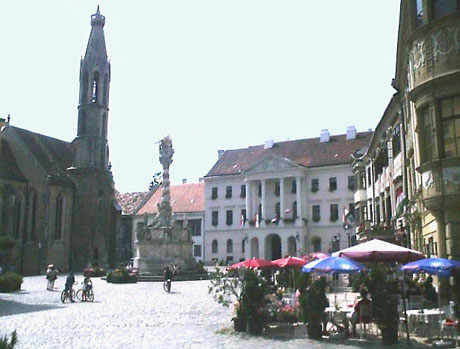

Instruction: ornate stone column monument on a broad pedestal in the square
[134,137,196,275]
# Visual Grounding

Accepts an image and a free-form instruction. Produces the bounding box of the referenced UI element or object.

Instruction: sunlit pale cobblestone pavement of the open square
[0,275,430,349]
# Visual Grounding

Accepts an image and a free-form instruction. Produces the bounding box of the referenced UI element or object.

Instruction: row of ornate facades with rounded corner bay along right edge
[352,0,460,260]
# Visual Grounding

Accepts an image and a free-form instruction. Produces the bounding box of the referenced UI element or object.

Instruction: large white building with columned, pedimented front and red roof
[204,127,372,263]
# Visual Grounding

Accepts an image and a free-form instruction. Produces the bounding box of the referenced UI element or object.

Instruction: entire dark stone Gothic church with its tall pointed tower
[0,8,120,274]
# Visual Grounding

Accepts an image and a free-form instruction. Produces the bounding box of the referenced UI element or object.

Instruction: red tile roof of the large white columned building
[206,132,373,177]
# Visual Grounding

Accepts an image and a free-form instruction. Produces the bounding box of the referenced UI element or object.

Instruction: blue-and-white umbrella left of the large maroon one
[302,257,365,274]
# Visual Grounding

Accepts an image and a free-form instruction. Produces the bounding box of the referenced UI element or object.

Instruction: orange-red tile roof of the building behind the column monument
[136,182,204,215]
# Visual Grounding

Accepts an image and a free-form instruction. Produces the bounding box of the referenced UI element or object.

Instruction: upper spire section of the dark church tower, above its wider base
[73,6,110,170]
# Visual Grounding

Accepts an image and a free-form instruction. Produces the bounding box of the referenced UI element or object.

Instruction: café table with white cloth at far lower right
[407,309,445,338]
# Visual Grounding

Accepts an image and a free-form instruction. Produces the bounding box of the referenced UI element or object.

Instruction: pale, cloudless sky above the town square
[0,0,399,193]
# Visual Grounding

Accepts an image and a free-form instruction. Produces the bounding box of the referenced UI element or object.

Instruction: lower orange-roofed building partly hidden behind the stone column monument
[131,181,204,262]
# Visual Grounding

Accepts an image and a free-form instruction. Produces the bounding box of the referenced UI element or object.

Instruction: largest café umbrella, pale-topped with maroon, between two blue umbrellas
[332,239,425,263]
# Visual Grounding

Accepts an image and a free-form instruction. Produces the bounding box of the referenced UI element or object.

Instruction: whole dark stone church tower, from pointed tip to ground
[68,6,120,270]
